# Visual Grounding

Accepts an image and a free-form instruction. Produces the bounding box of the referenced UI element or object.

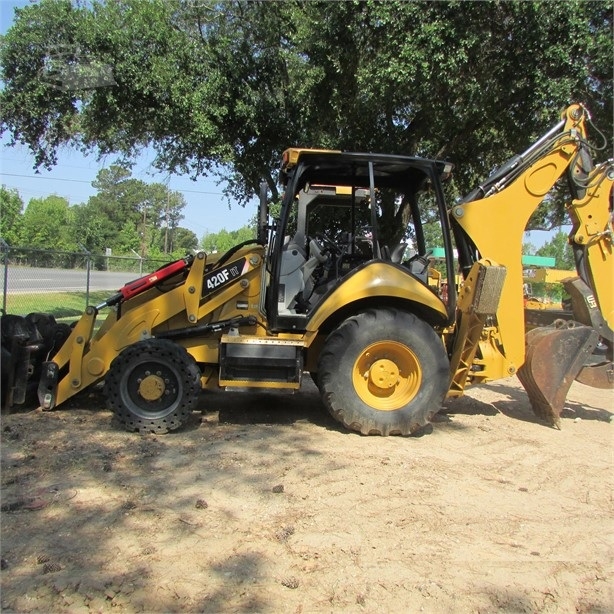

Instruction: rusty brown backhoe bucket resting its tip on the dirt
[518,320,599,428]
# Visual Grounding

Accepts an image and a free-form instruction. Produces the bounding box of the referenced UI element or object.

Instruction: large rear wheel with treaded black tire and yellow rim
[318,309,450,435]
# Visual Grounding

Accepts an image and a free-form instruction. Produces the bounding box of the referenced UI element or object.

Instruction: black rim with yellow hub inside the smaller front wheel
[122,360,181,419]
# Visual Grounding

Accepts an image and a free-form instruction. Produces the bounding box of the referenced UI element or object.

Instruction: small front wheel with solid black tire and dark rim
[104,339,201,433]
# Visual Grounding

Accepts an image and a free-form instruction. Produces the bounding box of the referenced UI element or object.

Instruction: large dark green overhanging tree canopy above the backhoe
[0,0,614,238]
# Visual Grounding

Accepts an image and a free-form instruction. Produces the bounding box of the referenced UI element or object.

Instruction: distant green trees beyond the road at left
[0,165,198,258]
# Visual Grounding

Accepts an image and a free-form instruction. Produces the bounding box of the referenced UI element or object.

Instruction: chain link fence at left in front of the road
[0,244,168,319]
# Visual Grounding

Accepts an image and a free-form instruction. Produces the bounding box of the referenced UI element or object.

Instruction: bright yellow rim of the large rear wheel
[352,341,422,411]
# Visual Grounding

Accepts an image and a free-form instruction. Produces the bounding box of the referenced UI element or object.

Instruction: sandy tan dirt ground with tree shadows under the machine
[0,379,614,614]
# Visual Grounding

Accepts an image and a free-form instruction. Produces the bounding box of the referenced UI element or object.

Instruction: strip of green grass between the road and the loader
[6,290,112,321]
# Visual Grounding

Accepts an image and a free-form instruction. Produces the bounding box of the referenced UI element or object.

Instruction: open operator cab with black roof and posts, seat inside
[266,149,453,330]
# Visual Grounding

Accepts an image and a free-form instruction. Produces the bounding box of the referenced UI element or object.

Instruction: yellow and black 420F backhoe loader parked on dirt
[5,105,614,435]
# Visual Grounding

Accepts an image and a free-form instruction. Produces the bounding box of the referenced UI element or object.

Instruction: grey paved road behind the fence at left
[0,266,139,294]
